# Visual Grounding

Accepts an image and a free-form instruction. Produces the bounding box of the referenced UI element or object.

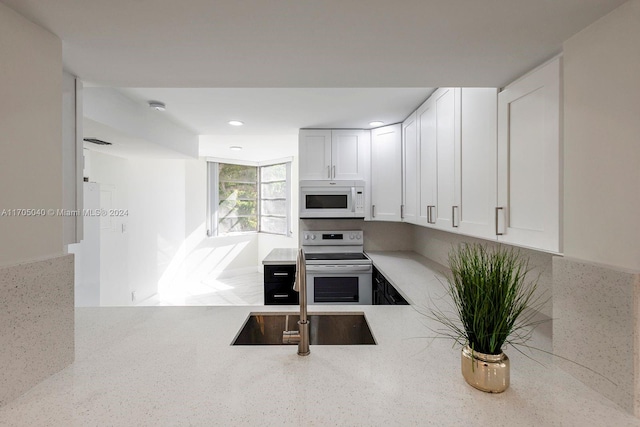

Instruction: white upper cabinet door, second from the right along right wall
[453,88,498,239]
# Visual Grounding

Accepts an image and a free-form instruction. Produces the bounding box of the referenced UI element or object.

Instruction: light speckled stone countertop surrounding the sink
[0,252,640,427]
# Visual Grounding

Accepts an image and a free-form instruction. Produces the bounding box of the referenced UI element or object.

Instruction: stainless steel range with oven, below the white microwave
[302,230,373,304]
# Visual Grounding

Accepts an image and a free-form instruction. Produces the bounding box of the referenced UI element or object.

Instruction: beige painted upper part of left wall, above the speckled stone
[0,4,63,266]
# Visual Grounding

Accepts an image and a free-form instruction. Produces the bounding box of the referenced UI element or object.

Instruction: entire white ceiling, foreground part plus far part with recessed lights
[0,0,625,134]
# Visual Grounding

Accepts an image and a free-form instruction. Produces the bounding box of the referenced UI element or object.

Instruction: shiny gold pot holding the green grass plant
[461,346,509,393]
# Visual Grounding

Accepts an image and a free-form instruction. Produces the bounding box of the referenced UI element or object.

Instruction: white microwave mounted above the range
[300,180,364,218]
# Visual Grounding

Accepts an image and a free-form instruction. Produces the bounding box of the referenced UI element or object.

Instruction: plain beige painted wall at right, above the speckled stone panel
[564,0,640,270]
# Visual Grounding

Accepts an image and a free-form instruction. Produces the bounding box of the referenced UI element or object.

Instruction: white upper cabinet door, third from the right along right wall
[432,88,460,231]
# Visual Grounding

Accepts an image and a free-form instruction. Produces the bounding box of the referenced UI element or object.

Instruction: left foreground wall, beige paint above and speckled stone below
[0,3,74,408]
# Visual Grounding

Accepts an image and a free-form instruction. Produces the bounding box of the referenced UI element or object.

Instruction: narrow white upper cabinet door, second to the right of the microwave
[401,113,420,224]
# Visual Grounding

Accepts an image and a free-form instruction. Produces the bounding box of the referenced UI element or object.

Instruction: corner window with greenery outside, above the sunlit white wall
[208,162,291,236]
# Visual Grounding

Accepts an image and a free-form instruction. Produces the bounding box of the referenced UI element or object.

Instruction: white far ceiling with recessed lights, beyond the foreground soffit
[117,88,432,135]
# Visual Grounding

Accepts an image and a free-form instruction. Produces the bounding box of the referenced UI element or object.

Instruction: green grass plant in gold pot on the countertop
[429,244,542,393]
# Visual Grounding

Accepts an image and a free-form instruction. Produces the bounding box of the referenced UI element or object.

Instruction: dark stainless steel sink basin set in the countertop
[232,312,376,345]
